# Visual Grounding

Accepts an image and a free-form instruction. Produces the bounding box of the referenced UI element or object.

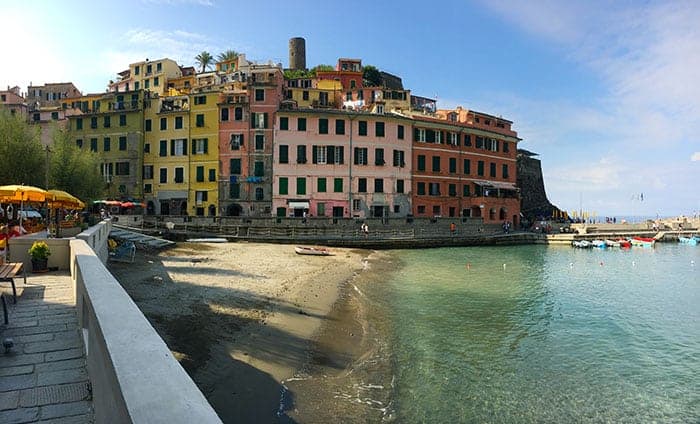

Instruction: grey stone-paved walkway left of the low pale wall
[0,271,93,424]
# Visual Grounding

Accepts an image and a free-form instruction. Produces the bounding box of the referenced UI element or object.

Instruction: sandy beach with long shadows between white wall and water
[109,243,370,422]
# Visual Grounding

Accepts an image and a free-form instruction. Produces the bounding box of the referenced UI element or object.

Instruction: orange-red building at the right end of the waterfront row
[411,108,520,225]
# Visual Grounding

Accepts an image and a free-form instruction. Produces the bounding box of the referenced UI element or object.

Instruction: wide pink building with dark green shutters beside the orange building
[272,109,412,217]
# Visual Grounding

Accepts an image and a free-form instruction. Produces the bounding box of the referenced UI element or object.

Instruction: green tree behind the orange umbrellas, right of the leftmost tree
[49,129,105,201]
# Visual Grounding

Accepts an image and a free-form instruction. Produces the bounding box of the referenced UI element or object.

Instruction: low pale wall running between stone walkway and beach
[70,229,221,423]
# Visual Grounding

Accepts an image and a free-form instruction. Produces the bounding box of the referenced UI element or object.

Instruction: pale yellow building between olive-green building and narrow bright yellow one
[143,90,190,215]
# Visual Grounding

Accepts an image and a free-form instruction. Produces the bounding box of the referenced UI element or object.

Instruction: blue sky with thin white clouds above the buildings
[0,0,700,217]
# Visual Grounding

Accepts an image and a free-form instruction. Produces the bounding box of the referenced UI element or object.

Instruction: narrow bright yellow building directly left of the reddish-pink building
[187,89,219,216]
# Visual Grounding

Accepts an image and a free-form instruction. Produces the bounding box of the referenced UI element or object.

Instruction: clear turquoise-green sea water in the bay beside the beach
[370,244,700,423]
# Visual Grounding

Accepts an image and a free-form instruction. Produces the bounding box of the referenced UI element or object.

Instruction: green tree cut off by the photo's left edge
[0,107,46,187]
